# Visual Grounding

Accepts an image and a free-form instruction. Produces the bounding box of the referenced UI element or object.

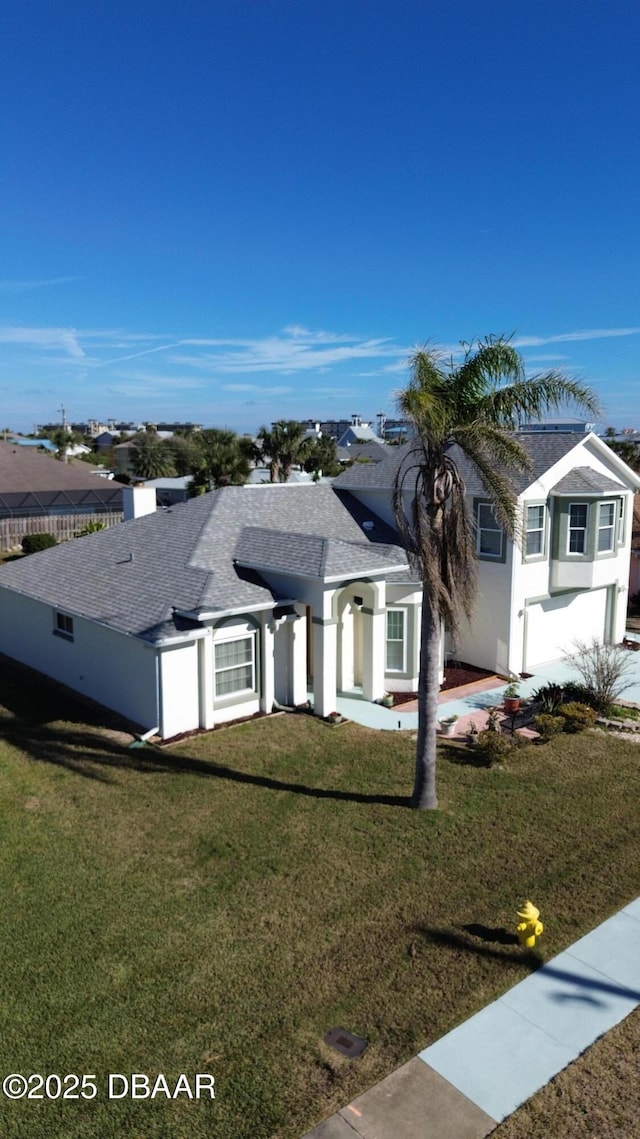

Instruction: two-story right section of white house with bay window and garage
[334,432,640,675]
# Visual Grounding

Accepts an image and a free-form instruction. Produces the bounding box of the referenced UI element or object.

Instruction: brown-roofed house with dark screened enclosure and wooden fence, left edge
[0,443,122,550]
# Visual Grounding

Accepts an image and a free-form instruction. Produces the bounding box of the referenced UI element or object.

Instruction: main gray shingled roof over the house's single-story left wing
[0,485,397,640]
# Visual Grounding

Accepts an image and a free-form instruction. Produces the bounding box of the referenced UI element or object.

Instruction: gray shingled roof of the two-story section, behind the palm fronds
[334,432,585,494]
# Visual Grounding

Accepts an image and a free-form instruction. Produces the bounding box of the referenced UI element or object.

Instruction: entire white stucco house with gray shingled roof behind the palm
[0,433,640,738]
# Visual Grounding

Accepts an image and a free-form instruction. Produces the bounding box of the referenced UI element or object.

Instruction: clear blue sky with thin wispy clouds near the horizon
[0,0,640,431]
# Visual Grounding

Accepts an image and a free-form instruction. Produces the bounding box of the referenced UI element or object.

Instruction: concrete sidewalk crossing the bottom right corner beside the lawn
[307,899,640,1139]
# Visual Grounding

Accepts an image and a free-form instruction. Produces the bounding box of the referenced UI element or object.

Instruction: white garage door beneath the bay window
[524,589,607,672]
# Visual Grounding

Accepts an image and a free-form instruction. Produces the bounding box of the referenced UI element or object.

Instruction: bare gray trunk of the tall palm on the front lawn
[411,589,441,811]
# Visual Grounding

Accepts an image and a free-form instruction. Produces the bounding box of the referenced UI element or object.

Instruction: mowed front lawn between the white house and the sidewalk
[0,662,640,1139]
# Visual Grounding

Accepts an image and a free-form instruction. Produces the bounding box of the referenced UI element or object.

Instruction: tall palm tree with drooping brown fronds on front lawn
[394,336,599,810]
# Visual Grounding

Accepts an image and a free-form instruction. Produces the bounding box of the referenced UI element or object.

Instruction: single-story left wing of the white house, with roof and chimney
[0,485,419,738]
